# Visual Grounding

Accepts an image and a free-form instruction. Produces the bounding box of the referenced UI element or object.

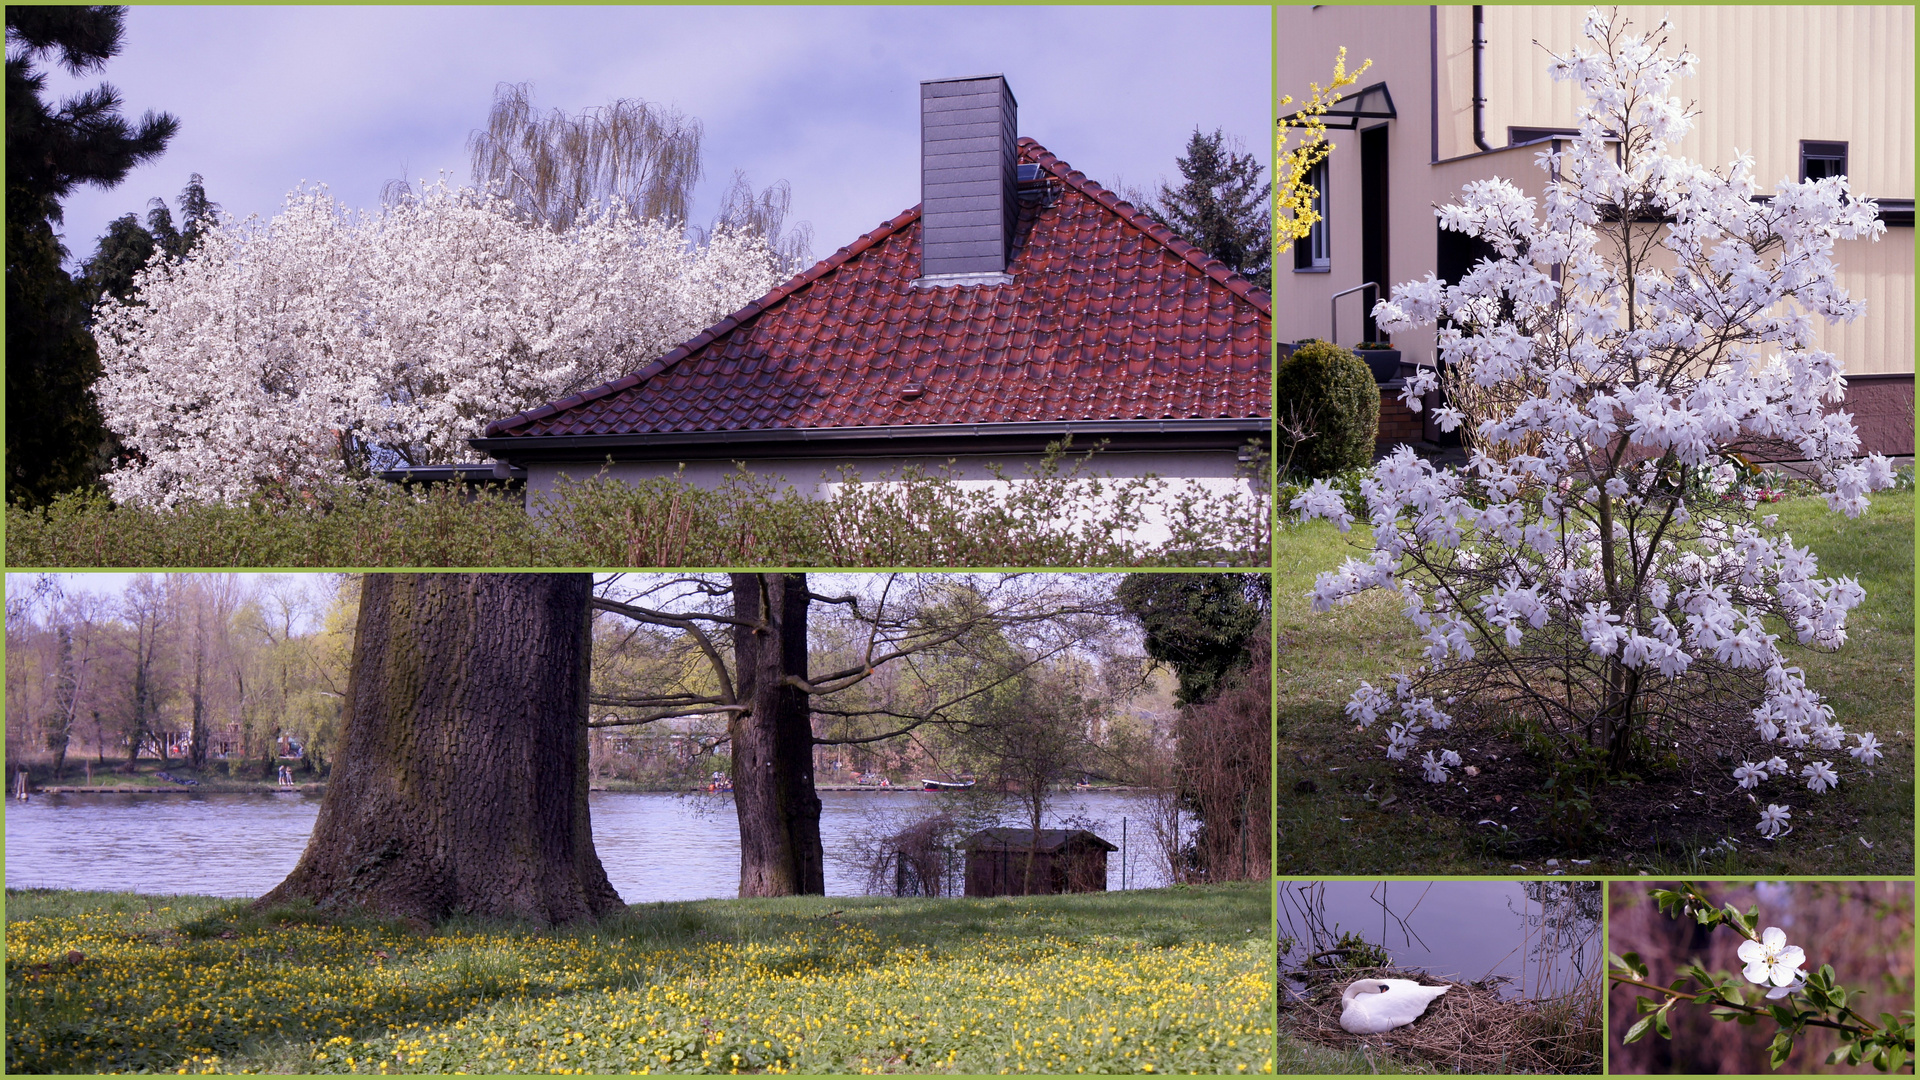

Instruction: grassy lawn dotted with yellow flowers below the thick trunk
[6,882,1273,1072]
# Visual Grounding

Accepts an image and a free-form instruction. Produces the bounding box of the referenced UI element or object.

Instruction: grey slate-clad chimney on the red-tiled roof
[914,75,1018,286]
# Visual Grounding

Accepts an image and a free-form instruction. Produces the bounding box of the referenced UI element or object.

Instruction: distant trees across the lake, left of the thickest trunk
[6,575,355,782]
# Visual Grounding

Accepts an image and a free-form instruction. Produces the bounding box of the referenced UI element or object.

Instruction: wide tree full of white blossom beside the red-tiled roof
[94,181,780,505]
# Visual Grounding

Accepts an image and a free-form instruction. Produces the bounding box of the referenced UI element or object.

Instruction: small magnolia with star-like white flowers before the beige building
[1292,12,1893,838]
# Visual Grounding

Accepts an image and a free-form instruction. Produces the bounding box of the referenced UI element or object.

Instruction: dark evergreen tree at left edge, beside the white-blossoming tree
[6,8,179,503]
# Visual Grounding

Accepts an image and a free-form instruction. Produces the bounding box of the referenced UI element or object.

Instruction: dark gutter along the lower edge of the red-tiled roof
[468,417,1273,467]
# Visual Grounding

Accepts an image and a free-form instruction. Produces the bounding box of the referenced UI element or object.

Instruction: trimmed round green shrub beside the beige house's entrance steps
[1275,340,1380,477]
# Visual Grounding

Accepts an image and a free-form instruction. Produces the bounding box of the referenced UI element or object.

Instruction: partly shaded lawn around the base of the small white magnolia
[1275,492,1914,874]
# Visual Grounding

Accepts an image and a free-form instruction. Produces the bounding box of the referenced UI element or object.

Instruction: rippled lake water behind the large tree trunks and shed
[6,780,1167,903]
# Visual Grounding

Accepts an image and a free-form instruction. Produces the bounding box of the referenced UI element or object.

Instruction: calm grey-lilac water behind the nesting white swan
[1279,880,1599,997]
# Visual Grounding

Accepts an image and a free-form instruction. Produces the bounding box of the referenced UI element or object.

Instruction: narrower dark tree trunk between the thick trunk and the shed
[728,575,828,896]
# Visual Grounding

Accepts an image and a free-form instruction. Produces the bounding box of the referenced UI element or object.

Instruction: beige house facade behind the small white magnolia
[1273,6,1914,454]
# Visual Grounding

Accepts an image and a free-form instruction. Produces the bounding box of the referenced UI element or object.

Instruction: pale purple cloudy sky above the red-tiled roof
[33,6,1273,261]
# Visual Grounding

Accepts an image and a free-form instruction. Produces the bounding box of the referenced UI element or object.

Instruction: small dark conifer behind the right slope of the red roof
[1148,127,1273,290]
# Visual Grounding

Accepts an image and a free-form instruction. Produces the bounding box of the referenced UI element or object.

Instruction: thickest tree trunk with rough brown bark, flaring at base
[257,575,622,924]
